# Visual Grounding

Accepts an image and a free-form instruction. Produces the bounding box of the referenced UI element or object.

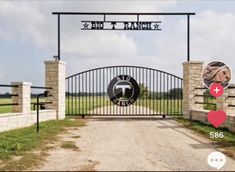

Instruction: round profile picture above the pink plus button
[203,61,231,88]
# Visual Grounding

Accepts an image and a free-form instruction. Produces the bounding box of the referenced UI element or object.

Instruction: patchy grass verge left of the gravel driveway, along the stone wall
[0,119,85,171]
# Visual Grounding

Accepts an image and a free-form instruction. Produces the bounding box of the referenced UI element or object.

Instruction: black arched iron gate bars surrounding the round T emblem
[66,66,183,116]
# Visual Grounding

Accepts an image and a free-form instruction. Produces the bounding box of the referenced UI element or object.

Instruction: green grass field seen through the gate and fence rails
[0,96,216,115]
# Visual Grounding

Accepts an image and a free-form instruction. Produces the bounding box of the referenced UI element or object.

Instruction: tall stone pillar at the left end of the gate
[45,61,66,119]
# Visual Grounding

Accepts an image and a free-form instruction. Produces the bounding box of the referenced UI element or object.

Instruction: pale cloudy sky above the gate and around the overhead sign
[0,0,235,86]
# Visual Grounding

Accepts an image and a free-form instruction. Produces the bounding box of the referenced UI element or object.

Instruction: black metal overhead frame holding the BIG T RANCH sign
[52,12,195,61]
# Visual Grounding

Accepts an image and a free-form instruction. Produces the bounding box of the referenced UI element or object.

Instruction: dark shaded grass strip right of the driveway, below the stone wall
[177,118,235,159]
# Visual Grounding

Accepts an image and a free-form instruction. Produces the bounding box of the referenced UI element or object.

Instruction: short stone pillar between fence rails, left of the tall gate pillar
[11,82,32,114]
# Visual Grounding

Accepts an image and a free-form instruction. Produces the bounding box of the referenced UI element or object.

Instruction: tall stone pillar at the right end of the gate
[182,61,203,119]
